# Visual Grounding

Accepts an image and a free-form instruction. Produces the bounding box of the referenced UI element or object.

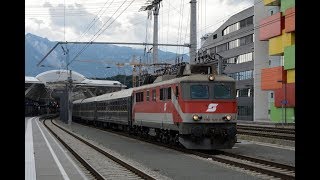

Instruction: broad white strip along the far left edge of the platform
[24,118,37,180]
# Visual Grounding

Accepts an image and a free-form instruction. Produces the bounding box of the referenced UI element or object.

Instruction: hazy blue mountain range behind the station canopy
[25,33,189,78]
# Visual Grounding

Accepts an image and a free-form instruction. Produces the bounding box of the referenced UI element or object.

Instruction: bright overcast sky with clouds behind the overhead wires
[25,0,253,53]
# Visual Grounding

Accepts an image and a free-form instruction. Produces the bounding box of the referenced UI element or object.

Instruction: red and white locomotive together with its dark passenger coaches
[73,65,237,149]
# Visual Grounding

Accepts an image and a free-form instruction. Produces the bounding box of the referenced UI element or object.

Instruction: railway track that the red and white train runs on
[72,120,295,179]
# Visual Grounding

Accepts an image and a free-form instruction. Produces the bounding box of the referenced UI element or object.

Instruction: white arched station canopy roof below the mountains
[25,70,126,101]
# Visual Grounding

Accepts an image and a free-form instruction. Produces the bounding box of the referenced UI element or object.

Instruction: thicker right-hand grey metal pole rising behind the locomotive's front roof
[189,0,197,64]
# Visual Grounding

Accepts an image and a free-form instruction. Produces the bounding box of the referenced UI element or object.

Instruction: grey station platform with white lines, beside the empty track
[25,117,88,180]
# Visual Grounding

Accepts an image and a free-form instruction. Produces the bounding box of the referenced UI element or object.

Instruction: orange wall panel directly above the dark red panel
[261,66,287,90]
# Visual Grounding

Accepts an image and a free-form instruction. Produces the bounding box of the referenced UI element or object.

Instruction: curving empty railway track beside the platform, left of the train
[43,119,155,180]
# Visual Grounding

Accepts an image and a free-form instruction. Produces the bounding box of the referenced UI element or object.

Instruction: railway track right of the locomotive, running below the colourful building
[237,125,295,141]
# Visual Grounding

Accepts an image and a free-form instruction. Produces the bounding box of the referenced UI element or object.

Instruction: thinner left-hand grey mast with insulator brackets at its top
[153,4,160,64]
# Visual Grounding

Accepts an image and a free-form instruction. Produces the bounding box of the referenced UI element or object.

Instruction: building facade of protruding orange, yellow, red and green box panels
[258,0,295,123]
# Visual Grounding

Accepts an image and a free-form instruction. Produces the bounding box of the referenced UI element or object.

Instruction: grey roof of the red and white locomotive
[134,74,234,91]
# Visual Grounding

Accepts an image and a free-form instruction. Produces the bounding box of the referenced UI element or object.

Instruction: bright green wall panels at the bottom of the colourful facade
[270,103,295,123]
